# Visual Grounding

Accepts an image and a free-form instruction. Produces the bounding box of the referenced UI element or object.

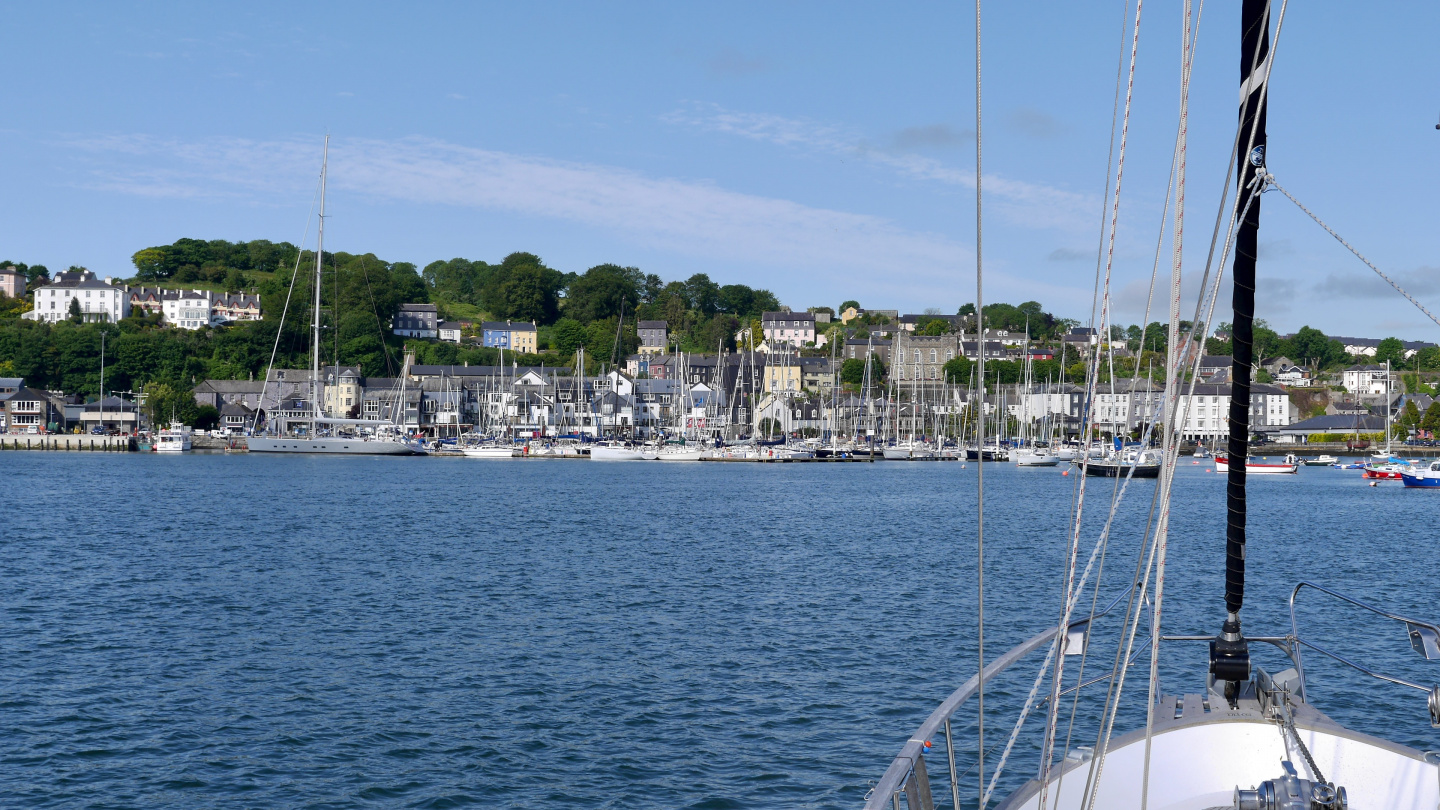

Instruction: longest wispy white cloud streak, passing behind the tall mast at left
[61,135,973,298]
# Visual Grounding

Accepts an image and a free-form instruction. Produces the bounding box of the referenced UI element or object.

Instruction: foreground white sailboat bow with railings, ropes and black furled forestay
[865,0,1440,810]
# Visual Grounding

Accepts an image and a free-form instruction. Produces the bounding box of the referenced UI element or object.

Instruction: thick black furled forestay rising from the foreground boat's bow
[1210,0,1270,702]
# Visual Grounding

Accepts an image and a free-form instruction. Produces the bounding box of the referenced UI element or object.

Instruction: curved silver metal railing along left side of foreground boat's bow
[865,584,1138,810]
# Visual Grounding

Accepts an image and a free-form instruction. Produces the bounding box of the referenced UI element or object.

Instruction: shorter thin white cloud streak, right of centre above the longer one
[661,102,1100,232]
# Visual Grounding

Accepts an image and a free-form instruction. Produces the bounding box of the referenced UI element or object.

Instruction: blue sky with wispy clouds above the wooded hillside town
[0,0,1440,340]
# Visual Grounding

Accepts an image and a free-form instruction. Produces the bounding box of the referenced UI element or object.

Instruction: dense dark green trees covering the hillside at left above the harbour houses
[0,239,779,406]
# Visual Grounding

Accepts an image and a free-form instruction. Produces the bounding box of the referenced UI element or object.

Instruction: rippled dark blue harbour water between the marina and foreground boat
[0,453,1440,809]
